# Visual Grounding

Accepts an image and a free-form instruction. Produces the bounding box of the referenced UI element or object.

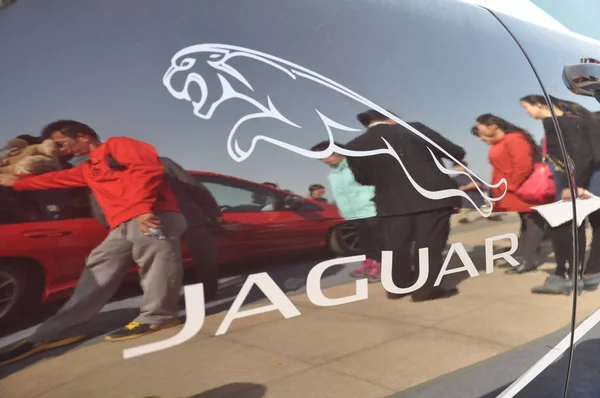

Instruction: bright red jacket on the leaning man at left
[13,137,179,229]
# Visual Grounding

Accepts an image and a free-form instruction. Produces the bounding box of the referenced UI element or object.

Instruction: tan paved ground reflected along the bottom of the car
[0,215,600,398]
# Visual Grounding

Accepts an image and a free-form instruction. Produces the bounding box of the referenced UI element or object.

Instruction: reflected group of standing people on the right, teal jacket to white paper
[311,95,600,301]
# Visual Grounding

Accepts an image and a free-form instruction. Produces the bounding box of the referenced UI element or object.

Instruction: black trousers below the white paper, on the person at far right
[550,216,591,277]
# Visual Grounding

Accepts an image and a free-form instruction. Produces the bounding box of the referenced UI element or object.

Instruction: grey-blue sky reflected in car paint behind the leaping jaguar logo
[0,0,596,199]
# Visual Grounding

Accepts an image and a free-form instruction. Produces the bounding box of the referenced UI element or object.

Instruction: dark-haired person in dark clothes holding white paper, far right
[520,95,600,294]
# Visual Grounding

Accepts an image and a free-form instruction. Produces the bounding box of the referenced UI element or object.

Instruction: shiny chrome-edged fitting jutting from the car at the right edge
[563,58,600,102]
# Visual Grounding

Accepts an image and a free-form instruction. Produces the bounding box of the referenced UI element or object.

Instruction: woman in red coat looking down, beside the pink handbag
[473,113,546,274]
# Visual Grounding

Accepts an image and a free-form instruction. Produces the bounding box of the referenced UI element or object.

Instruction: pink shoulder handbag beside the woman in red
[516,137,556,204]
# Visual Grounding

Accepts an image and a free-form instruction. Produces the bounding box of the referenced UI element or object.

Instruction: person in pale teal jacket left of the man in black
[311,141,381,282]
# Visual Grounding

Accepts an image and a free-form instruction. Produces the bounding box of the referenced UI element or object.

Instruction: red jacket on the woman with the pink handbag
[489,132,535,213]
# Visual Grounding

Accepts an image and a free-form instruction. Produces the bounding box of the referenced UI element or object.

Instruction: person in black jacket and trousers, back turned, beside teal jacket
[346,110,465,301]
